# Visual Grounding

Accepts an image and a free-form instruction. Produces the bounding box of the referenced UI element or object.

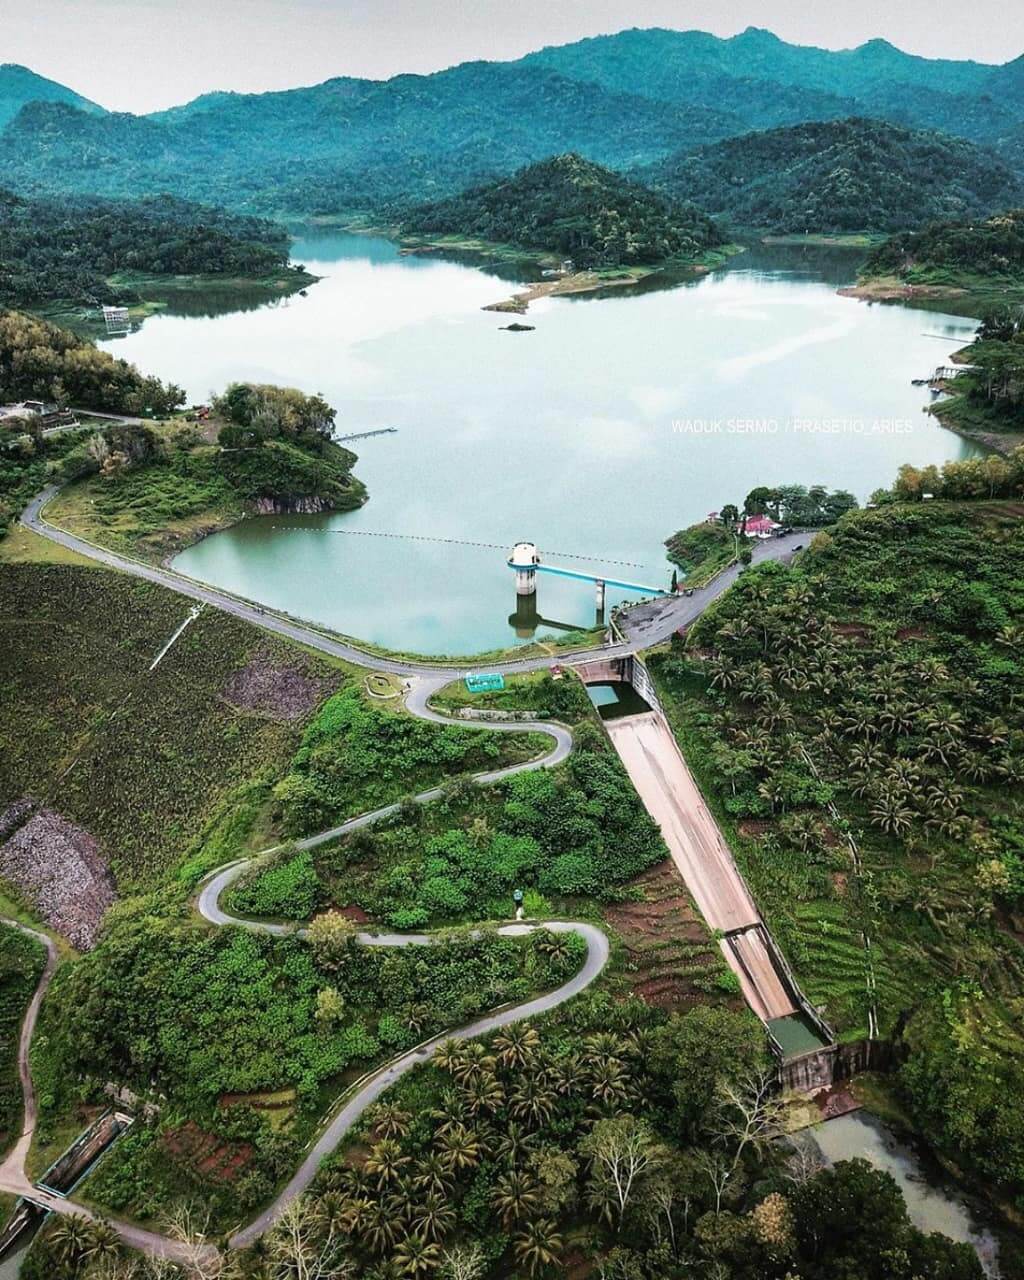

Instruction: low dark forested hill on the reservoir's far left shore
[0,189,299,307]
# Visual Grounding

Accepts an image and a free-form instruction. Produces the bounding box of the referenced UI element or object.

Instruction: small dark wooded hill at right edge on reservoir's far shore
[863,209,1024,283]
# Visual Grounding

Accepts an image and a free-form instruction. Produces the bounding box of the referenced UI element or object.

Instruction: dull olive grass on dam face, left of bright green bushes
[0,564,536,891]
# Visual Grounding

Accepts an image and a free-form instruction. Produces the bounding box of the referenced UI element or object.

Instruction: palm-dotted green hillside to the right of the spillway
[652,494,1024,1204]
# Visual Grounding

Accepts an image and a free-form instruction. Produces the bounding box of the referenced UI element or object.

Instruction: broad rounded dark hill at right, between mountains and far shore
[644,119,1024,232]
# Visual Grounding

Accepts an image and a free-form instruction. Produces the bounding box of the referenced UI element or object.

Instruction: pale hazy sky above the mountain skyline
[8,0,1024,111]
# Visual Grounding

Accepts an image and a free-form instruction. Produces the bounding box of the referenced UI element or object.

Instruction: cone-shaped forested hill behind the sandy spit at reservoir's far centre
[403,155,723,268]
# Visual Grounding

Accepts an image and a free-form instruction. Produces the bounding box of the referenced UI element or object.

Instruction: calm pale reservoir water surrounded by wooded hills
[97,234,974,654]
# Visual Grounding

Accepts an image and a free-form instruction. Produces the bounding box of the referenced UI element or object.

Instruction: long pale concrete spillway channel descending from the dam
[576,657,835,1089]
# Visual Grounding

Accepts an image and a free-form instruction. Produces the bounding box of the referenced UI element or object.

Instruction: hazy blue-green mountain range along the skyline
[0,28,1024,229]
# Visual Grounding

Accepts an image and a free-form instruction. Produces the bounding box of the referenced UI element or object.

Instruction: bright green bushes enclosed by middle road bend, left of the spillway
[229,722,664,929]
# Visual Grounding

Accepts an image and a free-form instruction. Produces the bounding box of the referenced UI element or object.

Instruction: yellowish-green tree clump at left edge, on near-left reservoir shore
[0,311,184,415]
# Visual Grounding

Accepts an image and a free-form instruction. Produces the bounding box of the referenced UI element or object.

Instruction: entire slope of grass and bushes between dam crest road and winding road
[0,564,540,891]
